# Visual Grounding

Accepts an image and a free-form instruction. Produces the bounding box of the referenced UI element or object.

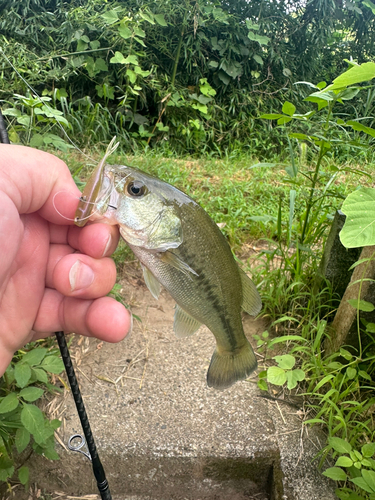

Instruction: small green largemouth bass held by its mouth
[75,161,262,389]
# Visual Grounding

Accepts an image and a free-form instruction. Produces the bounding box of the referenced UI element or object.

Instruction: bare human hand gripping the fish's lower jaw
[0,144,131,376]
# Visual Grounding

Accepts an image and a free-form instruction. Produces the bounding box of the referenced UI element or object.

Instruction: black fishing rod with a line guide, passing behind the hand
[0,110,112,500]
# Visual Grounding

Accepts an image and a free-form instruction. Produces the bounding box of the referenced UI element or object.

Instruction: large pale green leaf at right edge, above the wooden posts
[340,188,375,248]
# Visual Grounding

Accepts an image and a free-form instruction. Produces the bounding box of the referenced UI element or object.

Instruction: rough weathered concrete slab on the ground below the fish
[30,286,335,500]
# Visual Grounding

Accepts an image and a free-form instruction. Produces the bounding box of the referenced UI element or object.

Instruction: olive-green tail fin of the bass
[207,341,257,390]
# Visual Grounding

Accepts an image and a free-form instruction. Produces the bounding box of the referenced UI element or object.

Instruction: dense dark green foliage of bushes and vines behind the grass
[0,0,375,155]
